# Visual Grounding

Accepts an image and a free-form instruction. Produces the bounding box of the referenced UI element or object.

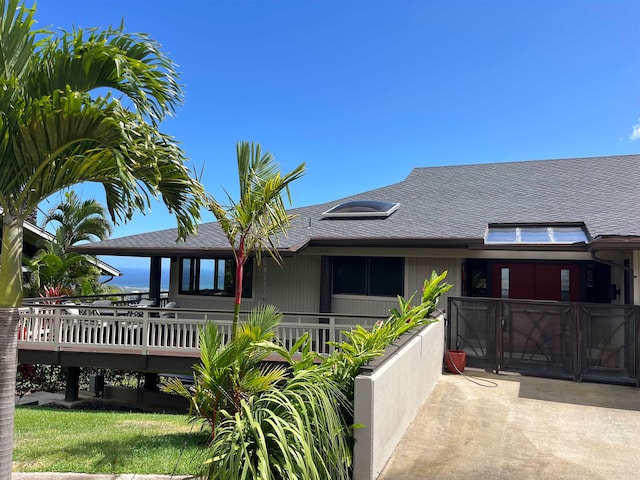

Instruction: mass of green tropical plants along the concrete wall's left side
[165,272,451,480]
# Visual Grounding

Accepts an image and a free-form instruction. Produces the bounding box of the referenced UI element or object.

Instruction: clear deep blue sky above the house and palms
[36,0,640,270]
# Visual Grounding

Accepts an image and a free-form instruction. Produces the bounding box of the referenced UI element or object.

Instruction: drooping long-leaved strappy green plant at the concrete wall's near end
[208,370,351,480]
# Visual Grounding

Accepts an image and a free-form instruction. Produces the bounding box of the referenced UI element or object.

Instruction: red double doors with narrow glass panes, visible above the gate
[493,263,580,302]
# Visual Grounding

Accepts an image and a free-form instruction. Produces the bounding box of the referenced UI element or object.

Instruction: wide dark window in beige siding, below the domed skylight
[333,257,404,297]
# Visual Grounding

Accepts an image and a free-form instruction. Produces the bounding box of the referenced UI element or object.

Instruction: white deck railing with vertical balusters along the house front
[18,304,385,356]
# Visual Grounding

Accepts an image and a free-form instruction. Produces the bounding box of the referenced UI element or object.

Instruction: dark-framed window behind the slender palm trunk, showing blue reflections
[180,258,253,298]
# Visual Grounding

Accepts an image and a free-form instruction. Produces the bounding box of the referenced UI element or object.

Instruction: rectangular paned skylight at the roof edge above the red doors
[484,224,589,245]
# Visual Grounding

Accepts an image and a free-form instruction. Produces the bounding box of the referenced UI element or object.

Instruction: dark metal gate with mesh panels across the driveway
[447,297,640,386]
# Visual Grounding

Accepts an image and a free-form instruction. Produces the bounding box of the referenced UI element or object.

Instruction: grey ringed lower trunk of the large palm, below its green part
[0,308,20,480]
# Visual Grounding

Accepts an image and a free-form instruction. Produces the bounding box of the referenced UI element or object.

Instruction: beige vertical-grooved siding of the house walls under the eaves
[170,248,640,315]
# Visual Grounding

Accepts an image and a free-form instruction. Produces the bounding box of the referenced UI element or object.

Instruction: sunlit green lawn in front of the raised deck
[13,407,209,475]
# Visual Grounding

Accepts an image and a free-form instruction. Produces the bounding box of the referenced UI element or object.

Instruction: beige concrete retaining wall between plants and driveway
[353,318,445,480]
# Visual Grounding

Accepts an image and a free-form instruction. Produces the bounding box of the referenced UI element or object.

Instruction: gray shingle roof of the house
[72,155,640,255]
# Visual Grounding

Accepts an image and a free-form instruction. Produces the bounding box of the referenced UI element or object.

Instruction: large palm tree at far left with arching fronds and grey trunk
[0,0,204,472]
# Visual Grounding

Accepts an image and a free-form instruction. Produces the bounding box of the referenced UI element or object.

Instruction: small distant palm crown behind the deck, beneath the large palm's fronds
[42,190,113,252]
